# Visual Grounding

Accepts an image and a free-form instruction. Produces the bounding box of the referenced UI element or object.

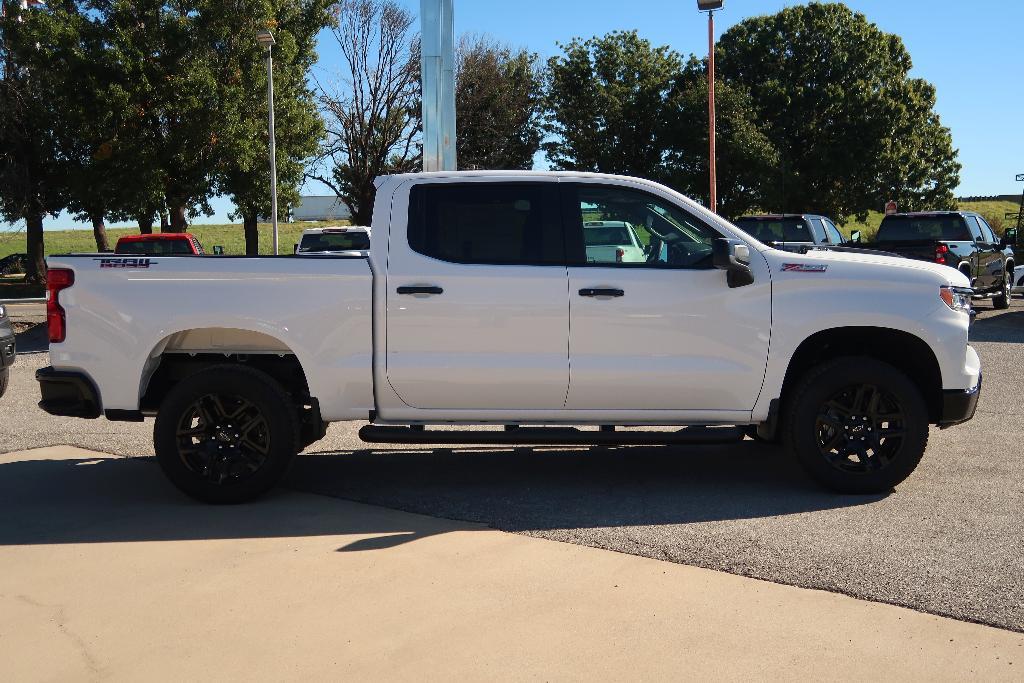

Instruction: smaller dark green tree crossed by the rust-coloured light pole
[666,57,778,217]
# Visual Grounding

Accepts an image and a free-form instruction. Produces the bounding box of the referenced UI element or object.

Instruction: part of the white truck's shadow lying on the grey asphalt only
[286,440,884,531]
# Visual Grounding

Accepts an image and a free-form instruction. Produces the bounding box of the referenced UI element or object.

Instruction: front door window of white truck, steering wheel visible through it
[562,183,721,268]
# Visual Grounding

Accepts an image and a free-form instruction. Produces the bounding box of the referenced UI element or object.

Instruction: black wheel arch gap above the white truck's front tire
[780,327,942,423]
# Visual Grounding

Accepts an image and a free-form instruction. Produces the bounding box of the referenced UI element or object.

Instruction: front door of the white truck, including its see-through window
[562,181,771,411]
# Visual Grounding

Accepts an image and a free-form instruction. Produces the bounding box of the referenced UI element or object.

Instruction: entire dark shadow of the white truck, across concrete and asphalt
[0,441,881,551]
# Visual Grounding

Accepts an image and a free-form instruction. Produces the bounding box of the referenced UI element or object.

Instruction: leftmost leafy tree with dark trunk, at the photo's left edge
[0,0,66,284]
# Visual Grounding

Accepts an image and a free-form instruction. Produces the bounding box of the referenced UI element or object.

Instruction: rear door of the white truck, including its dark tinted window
[384,177,569,411]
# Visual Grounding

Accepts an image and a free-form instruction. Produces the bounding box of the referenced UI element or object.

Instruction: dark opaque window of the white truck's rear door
[409,182,565,265]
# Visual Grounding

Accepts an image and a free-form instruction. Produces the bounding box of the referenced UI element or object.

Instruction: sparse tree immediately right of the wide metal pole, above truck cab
[455,36,544,169]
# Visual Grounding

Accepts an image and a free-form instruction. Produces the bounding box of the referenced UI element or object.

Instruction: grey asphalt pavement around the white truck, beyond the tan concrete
[0,298,1024,637]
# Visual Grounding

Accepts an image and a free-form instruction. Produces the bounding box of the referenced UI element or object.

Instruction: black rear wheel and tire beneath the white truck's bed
[154,365,299,503]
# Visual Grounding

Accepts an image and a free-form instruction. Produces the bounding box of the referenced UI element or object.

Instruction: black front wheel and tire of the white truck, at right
[786,356,929,494]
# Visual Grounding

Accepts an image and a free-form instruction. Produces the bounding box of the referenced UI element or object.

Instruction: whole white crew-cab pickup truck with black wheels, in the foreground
[37,171,981,502]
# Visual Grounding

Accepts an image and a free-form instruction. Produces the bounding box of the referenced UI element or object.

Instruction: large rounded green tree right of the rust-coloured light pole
[716,2,959,218]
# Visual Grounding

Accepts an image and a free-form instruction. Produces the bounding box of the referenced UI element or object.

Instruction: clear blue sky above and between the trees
[9,0,1024,227]
